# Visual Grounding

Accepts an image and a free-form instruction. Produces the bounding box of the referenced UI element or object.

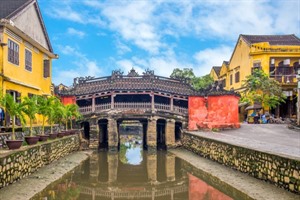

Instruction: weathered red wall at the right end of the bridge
[188,95,240,131]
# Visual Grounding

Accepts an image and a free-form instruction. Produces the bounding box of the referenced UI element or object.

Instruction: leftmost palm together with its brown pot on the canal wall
[0,93,25,149]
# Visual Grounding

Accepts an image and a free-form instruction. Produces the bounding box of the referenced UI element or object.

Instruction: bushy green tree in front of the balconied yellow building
[241,69,286,108]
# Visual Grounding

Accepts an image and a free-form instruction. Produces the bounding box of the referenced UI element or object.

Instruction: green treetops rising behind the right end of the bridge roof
[170,68,214,90]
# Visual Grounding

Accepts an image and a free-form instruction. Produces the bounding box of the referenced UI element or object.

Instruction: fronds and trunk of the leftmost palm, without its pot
[0,93,26,140]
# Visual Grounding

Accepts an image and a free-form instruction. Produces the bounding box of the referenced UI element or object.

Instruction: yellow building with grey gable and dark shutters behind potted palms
[0,0,57,126]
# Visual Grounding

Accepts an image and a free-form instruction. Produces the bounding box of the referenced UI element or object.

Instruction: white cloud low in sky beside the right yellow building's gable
[194,46,233,76]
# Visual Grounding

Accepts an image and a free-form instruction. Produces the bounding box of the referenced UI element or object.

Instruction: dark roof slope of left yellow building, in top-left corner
[0,0,33,19]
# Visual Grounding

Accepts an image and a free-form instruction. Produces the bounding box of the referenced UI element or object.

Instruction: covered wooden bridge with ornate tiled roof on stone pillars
[56,69,195,150]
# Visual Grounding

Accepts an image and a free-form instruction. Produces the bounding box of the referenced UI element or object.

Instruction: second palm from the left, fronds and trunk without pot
[22,95,38,136]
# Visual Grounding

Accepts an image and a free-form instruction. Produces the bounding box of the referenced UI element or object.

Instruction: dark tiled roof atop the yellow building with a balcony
[241,34,300,45]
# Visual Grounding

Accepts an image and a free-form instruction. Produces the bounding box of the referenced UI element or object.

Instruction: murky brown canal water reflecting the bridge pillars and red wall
[34,151,244,200]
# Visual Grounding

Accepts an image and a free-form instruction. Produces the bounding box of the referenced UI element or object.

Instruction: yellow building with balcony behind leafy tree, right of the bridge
[211,35,300,118]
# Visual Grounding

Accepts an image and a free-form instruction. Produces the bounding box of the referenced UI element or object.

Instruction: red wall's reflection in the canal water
[188,174,233,200]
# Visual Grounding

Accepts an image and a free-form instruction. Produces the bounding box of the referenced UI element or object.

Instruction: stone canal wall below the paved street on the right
[182,133,300,194]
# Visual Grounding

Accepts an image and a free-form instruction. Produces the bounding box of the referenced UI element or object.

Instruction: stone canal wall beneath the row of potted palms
[0,135,80,188]
